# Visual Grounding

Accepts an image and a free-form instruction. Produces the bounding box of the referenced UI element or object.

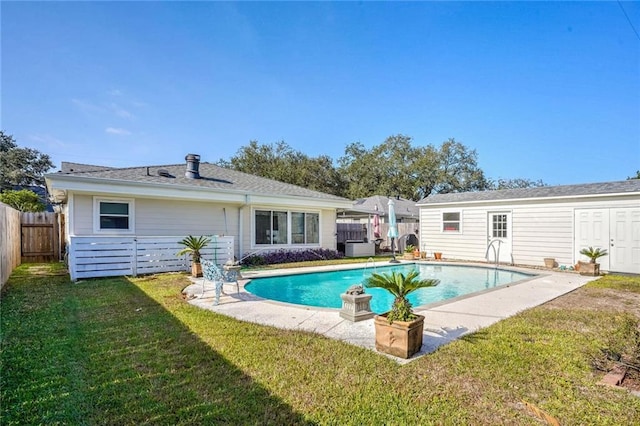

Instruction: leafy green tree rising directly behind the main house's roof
[218,140,345,196]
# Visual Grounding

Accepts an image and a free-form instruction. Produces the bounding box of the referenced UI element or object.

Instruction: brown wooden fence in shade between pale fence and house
[20,212,64,263]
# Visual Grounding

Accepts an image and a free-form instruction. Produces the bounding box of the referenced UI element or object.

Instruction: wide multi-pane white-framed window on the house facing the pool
[254,210,320,245]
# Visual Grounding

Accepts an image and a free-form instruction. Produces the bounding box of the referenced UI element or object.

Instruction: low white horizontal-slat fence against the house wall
[69,236,234,281]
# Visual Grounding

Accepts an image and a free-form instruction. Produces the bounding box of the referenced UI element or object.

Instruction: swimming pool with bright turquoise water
[245,263,534,314]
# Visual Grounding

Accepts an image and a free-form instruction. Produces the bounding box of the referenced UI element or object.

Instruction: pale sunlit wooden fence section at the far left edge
[0,203,21,288]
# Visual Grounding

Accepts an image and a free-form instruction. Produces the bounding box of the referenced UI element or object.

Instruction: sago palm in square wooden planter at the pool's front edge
[364,271,440,359]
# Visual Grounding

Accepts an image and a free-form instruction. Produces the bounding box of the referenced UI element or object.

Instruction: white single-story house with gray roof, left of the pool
[45,154,352,280]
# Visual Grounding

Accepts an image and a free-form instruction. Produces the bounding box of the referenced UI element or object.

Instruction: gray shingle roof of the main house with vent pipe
[50,162,346,201]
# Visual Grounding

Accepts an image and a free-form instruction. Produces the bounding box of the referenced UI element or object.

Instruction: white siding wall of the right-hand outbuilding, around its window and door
[420,196,639,267]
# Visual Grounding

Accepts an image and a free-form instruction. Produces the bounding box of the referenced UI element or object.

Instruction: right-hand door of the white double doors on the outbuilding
[608,208,640,274]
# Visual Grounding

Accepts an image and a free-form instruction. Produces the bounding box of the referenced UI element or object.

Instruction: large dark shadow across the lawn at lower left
[0,266,311,424]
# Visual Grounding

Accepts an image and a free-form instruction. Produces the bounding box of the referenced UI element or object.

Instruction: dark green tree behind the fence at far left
[0,130,54,192]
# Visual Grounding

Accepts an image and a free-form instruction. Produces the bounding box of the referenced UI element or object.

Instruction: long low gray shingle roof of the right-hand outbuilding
[418,179,640,204]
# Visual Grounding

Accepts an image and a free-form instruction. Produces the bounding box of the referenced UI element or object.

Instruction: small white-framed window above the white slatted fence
[93,198,134,234]
